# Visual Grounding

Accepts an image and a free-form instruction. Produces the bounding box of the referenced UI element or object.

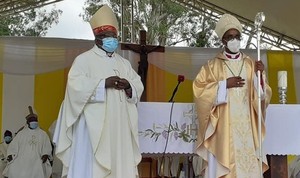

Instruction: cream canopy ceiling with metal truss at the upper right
[173,0,300,50]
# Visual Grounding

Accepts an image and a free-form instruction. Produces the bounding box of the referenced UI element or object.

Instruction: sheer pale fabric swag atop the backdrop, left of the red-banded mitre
[0,37,93,75]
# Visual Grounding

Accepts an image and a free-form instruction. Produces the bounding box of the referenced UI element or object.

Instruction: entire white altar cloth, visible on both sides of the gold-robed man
[138,102,300,155]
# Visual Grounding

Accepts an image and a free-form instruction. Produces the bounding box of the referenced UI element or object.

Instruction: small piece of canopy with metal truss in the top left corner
[0,0,62,17]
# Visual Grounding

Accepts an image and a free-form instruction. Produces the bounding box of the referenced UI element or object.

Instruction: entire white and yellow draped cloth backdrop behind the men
[0,37,300,149]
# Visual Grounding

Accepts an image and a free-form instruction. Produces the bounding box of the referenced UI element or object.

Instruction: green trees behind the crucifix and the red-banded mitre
[81,0,218,47]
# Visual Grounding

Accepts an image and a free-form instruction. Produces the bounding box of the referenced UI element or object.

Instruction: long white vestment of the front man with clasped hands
[53,46,143,178]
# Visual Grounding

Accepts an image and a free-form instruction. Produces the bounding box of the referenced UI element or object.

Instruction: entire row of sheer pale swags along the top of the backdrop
[0,37,267,80]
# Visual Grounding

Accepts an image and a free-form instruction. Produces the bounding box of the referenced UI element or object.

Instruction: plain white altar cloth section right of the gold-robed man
[263,104,300,155]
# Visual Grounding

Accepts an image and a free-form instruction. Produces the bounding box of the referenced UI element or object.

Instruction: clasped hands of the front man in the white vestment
[105,76,130,90]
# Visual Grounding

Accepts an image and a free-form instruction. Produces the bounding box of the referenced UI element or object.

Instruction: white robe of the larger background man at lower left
[5,127,52,178]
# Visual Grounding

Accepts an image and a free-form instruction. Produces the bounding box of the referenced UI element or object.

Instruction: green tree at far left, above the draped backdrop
[0,7,62,36]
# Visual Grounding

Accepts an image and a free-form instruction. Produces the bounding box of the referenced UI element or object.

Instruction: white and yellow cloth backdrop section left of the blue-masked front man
[0,37,93,136]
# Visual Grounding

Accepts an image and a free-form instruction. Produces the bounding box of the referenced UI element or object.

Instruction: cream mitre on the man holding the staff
[215,14,243,39]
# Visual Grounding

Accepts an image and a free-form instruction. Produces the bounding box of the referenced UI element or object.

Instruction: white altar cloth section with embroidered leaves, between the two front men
[138,102,197,154]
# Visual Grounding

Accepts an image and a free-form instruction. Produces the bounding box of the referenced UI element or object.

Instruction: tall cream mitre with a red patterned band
[90,5,119,35]
